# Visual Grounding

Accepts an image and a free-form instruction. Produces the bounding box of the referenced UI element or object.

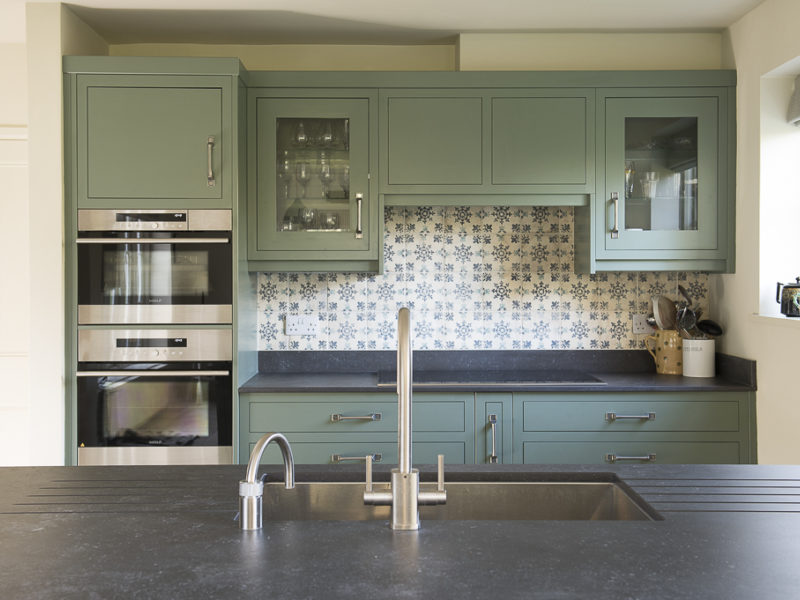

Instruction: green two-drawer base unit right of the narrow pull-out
[513,392,756,464]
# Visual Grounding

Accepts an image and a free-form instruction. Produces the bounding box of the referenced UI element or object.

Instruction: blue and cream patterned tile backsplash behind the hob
[258,206,710,350]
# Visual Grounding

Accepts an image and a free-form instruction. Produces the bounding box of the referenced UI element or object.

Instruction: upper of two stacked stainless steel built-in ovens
[77,210,233,325]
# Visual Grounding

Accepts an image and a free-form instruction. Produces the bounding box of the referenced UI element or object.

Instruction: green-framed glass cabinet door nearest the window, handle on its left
[605,97,718,250]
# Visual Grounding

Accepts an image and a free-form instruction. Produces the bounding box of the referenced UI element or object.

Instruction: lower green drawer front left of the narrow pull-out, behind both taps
[255,440,468,465]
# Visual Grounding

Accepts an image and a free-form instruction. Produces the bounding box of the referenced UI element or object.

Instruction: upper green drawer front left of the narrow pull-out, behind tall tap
[249,400,467,434]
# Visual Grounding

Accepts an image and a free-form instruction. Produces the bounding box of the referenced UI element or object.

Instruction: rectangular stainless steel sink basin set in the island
[263,481,662,522]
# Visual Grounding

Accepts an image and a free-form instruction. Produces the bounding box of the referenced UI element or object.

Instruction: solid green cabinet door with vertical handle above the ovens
[76,75,231,208]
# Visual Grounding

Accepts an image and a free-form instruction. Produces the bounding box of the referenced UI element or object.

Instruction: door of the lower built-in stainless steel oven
[77,362,233,465]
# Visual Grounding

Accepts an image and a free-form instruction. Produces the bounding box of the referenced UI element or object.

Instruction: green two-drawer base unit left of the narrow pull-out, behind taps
[238,392,475,464]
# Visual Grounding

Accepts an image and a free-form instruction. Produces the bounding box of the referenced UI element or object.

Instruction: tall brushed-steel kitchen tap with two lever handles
[364,307,447,531]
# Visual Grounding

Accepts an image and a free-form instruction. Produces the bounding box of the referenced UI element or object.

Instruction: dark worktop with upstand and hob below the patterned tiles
[239,350,756,393]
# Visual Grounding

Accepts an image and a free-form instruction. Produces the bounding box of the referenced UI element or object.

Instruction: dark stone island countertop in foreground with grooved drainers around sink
[0,465,800,600]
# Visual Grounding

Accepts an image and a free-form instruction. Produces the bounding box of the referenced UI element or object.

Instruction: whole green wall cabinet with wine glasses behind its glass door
[247,88,382,271]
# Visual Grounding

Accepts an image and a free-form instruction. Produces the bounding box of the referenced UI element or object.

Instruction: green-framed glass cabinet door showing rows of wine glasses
[256,98,370,250]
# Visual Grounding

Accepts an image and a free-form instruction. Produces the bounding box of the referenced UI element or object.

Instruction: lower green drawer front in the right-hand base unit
[522,441,740,464]
